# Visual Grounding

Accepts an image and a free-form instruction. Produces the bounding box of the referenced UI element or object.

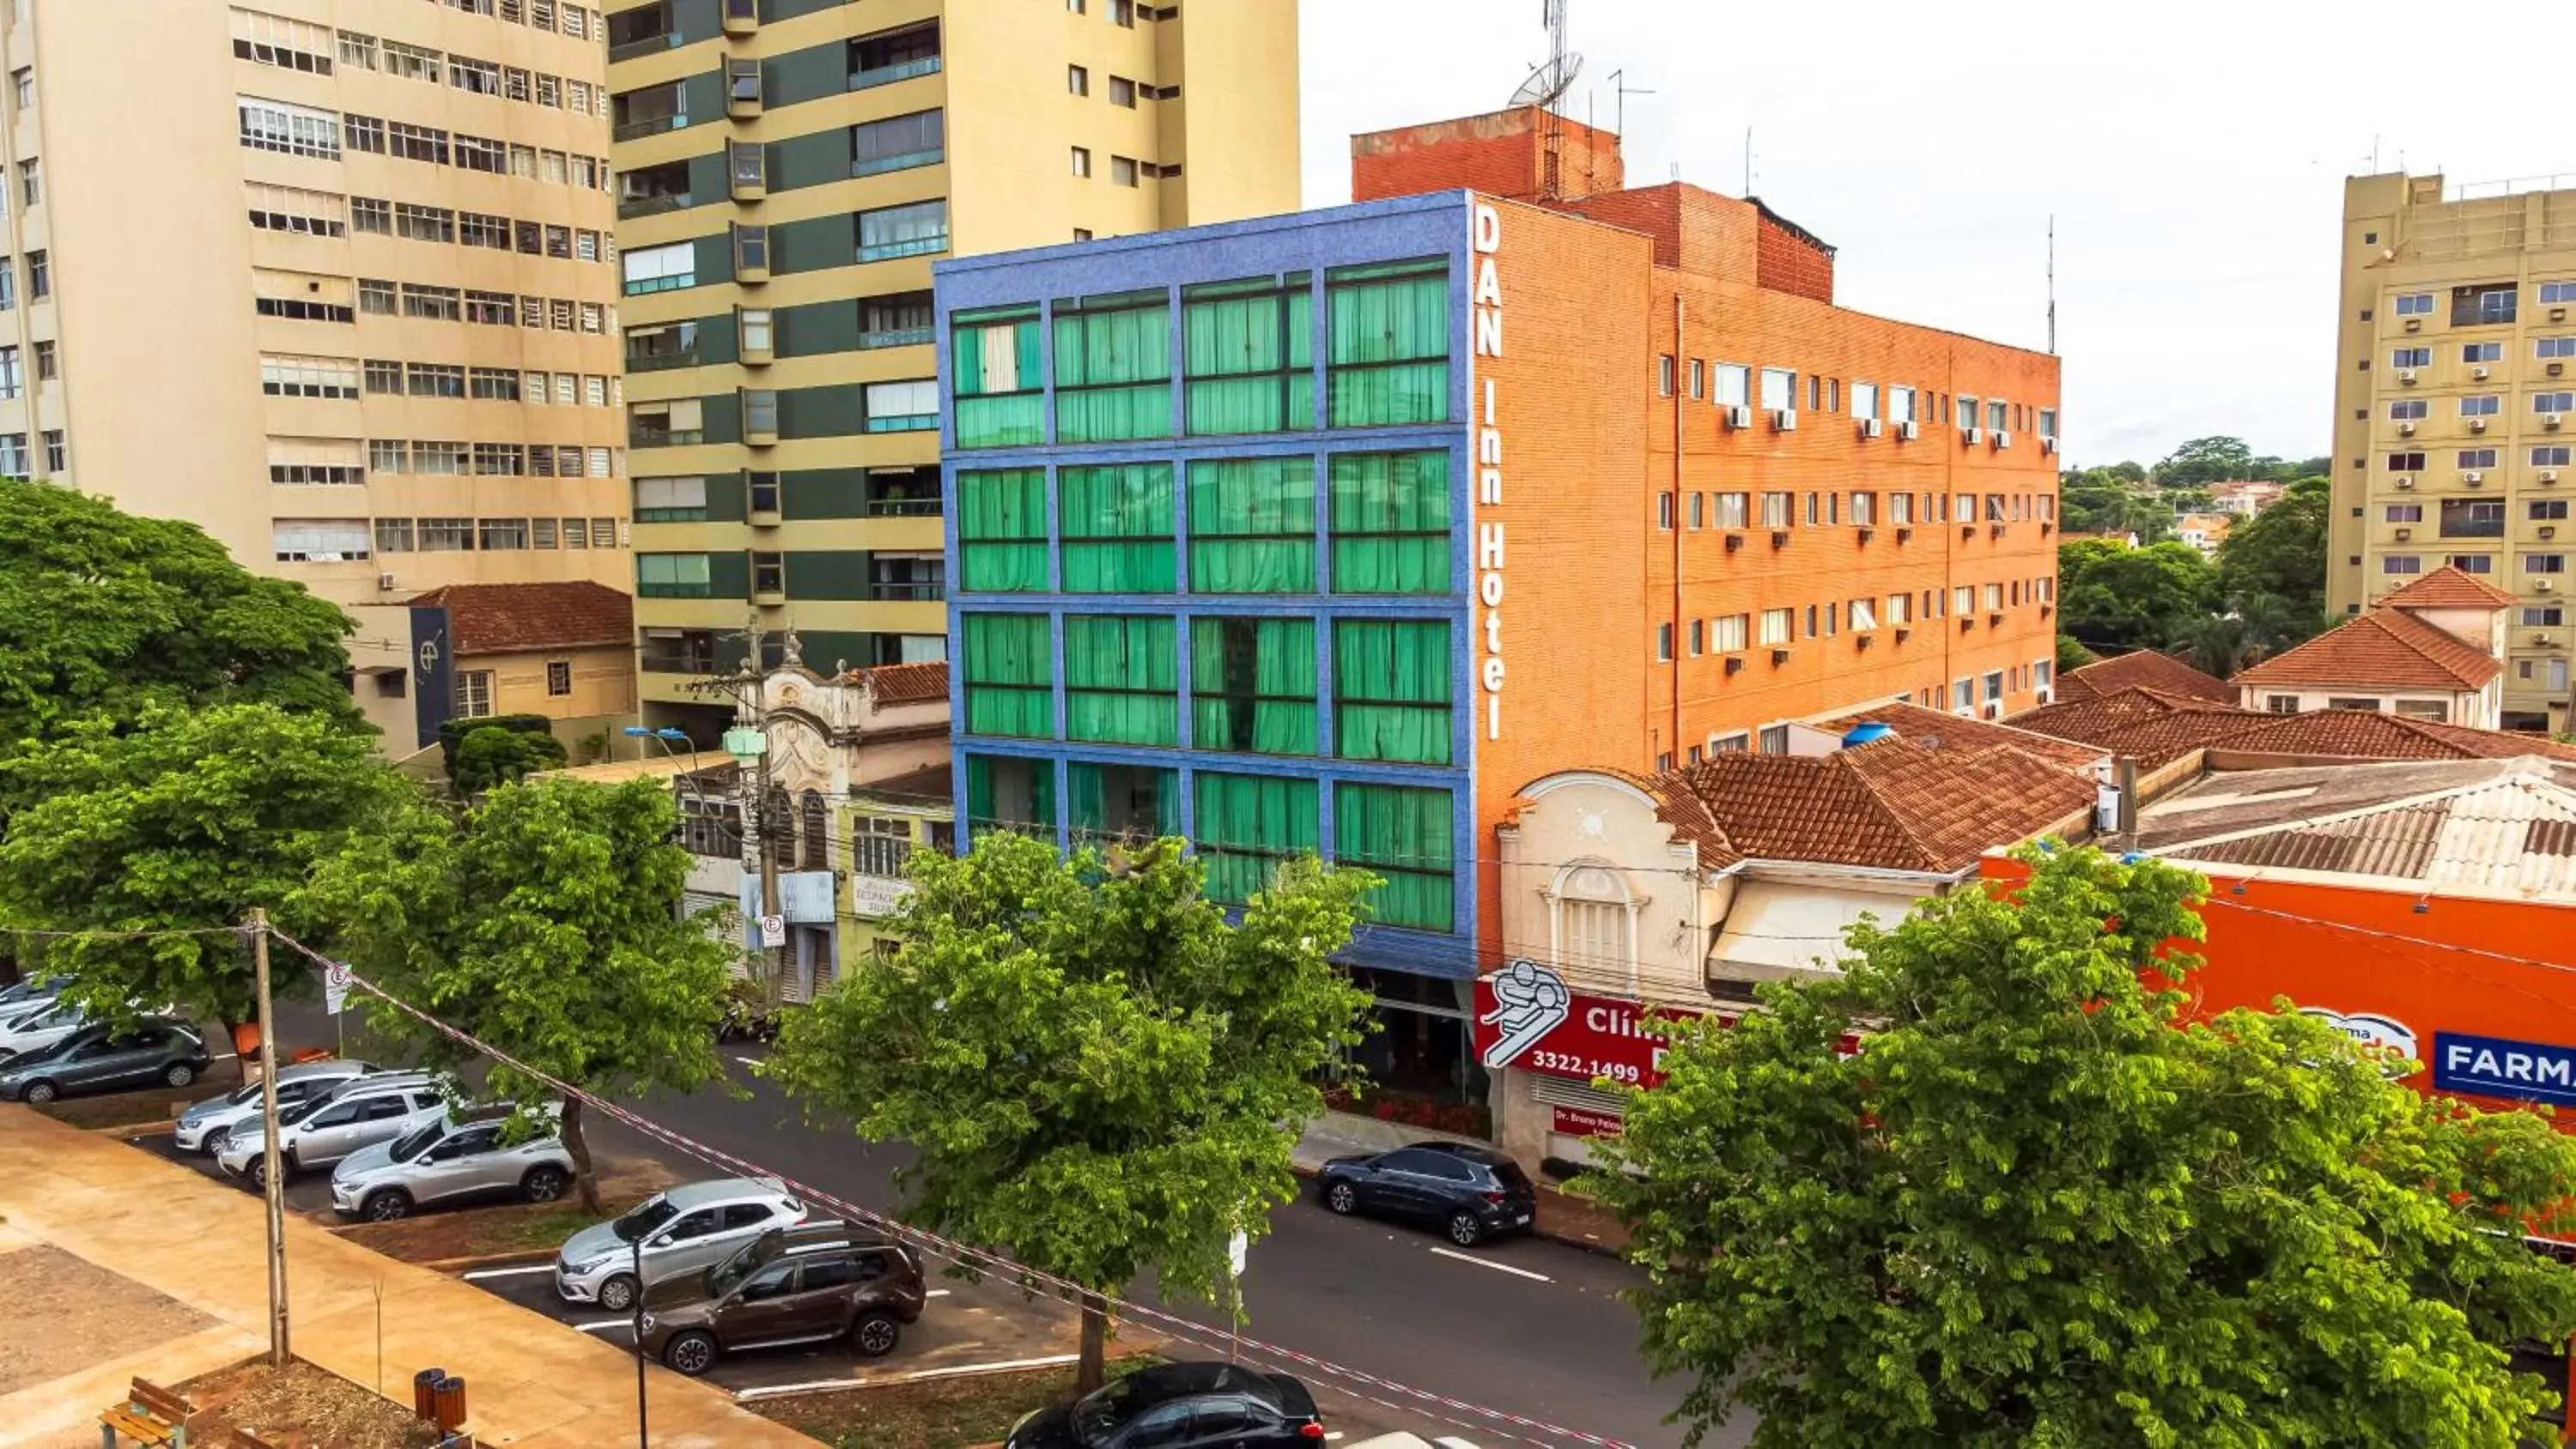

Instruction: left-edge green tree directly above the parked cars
[0,703,417,1027]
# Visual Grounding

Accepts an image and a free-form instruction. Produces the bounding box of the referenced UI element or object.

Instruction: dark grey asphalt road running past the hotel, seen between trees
[251,1006,1749,1449]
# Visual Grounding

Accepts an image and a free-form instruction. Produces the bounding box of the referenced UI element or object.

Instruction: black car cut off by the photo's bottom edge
[1002,1364,1324,1449]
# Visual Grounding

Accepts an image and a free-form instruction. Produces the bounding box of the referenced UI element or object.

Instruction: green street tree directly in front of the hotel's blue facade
[765,834,1376,1390]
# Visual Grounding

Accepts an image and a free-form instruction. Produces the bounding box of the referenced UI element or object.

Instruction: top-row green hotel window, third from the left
[1180,273,1314,438]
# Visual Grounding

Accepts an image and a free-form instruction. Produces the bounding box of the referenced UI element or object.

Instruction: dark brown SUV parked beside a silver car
[644,1222,925,1377]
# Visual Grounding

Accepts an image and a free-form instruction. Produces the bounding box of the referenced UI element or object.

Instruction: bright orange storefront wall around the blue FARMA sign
[1984,857,2576,1130]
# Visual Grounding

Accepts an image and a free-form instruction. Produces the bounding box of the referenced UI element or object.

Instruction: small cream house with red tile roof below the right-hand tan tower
[2231,567,2517,728]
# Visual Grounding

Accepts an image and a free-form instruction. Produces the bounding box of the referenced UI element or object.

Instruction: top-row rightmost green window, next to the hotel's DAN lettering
[1324,260,1450,427]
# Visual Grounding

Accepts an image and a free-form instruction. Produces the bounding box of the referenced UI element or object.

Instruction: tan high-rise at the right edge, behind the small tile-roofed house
[2326,175,2576,731]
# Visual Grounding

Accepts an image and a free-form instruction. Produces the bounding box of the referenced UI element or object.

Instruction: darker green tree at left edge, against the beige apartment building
[0,479,363,777]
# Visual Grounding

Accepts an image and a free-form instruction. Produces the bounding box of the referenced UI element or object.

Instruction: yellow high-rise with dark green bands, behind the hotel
[608,0,1298,738]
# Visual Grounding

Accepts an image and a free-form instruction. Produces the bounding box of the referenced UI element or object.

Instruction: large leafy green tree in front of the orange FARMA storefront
[1592,849,2576,1449]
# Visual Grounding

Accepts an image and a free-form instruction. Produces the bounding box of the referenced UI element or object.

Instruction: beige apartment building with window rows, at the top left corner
[0,0,634,754]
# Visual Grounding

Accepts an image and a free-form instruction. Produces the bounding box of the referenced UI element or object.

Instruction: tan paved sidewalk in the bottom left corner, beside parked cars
[0,1106,814,1449]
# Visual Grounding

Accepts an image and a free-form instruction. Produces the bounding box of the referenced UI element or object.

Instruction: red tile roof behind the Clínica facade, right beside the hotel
[1662,736,2094,872]
